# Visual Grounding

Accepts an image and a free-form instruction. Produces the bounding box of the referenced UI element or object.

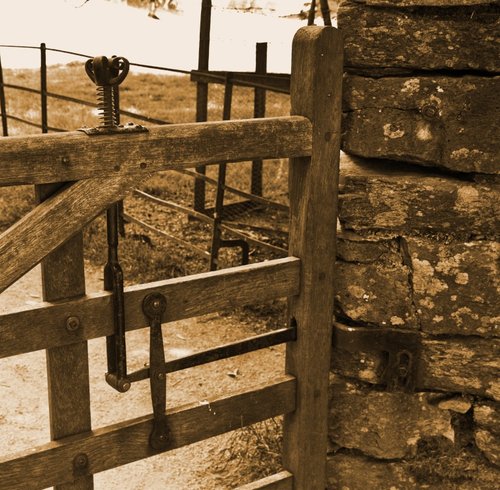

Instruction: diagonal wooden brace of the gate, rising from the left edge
[0,175,146,293]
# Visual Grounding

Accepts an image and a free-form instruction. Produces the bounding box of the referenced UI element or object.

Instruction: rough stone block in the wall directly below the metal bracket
[329,376,455,459]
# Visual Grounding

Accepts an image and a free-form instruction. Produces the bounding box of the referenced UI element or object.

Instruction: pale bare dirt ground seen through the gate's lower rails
[0,267,284,490]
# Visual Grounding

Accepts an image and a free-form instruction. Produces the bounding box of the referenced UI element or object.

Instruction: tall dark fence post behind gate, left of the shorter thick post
[193,0,212,212]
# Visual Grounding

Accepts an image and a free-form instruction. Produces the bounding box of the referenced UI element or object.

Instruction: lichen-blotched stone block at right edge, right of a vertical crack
[405,237,500,337]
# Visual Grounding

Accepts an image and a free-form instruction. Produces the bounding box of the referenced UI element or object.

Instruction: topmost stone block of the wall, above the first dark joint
[338,1,500,72]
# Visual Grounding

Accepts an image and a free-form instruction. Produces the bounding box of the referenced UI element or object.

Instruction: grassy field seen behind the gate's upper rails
[0,61,289,283]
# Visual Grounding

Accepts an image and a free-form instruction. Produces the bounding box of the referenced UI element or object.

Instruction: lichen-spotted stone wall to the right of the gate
[328,0,500,490]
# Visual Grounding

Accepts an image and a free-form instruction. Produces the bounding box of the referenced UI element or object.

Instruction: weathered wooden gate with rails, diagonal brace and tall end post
[0,27,342,490]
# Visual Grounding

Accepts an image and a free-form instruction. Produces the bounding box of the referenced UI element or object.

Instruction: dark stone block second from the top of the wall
[342,75,500,174]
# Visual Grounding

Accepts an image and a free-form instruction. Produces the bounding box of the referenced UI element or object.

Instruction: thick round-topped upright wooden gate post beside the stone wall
[283,26,343,490]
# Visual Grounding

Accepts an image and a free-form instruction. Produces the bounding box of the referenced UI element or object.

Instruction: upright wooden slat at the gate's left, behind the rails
[36,184,94,490]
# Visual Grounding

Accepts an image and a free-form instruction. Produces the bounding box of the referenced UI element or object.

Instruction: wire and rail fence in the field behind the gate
[0,43,290,269]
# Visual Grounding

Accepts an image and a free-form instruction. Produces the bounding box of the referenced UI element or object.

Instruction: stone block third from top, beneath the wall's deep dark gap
[339,154,500,240]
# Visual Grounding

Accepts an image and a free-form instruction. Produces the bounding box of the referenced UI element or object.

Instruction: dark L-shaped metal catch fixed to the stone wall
[333,322,421,392]
